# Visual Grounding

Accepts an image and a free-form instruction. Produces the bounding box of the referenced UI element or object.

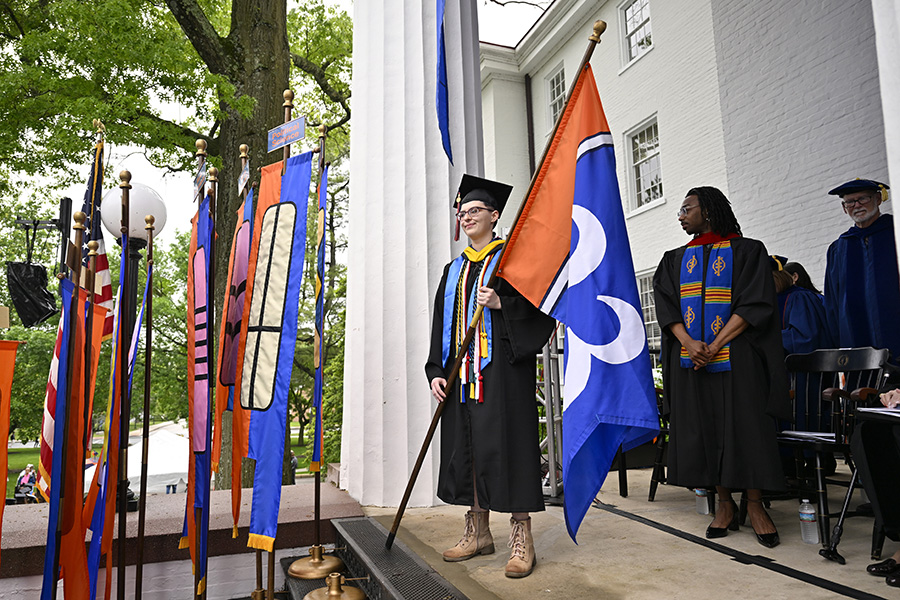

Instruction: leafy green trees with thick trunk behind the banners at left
[0,0,352,482]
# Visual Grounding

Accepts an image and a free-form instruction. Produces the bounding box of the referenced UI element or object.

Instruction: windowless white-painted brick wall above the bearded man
[713,0,891,286]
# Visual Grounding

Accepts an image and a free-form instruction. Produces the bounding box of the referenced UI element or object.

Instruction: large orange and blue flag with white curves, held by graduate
[500,64,659,540]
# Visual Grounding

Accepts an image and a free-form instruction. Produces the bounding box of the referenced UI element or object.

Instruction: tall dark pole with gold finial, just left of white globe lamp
[117,171,134,600]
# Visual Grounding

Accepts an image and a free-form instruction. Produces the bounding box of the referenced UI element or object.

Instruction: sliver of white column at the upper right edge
[872,0,900,260]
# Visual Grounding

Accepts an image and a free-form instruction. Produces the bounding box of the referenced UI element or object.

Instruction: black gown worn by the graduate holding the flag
[425,265,556,512]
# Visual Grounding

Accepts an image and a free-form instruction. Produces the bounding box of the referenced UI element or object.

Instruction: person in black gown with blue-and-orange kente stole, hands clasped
[653,187,790,547]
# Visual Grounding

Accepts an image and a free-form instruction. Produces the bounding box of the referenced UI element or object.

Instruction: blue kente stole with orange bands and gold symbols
[681,240,733,373]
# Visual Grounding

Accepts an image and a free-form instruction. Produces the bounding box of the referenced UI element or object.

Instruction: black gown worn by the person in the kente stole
[653,237,790,490]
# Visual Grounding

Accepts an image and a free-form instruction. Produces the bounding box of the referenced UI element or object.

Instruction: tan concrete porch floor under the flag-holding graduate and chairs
[365,470,900,600]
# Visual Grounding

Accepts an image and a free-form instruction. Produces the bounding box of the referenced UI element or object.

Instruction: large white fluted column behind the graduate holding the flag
[341,0,483,506]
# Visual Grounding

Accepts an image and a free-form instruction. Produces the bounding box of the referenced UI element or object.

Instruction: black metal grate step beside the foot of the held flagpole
[331,517,467,600]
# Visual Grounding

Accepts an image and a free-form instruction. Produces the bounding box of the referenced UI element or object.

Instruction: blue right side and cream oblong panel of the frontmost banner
[240,152,313,552]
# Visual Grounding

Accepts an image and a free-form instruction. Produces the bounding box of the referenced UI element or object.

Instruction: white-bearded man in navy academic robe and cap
[825,179,900,364]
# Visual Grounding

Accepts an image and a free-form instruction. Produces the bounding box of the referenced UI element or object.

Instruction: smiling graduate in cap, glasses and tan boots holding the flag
[425,175,556,577]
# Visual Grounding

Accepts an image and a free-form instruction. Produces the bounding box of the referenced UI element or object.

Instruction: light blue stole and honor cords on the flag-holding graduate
[441,239,504,402]
